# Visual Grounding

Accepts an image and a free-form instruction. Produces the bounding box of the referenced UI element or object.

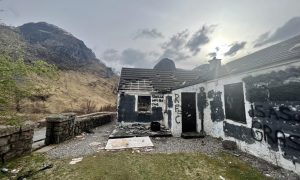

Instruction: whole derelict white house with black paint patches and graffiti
[118,36,300,174]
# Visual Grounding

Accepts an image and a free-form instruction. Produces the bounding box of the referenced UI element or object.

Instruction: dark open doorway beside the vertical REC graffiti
[181,93,196,133]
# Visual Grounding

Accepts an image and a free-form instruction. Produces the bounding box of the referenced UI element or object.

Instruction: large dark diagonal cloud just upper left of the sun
[186,25,216,56]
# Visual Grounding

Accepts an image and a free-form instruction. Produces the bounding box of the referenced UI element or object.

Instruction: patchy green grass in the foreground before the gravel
[0,151,267,180]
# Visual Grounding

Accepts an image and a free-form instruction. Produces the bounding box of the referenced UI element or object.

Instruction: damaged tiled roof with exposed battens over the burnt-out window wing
[118,59,198,92]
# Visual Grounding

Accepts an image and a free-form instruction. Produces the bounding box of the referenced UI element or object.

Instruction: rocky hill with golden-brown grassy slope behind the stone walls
[0,22,118,113]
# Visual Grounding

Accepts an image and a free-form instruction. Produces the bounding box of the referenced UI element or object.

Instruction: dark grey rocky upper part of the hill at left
[0,22,114,77]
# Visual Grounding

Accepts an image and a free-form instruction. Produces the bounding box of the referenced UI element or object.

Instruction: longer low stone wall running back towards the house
[45,113,116,145]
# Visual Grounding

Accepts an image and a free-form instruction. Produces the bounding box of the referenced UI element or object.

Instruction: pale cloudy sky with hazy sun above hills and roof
[0,0,300,71]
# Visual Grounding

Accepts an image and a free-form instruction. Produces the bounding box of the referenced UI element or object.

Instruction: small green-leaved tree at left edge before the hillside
[0,54,58,124]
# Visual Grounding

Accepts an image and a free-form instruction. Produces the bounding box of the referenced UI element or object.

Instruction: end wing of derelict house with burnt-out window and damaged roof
[118,59,198,127]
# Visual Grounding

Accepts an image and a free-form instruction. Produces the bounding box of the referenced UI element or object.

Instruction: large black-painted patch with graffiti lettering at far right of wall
[243,68,300,162]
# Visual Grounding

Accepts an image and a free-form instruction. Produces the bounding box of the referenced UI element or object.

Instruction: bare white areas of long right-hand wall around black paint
[171,59,300,174]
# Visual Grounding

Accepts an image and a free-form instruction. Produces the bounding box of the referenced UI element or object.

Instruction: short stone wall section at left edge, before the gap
[0,123,34,162]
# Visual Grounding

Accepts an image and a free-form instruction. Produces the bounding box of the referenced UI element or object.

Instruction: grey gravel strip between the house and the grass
[47,122,300,180]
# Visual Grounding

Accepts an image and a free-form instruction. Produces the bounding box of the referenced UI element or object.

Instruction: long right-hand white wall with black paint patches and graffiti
[171,59,300,174]
